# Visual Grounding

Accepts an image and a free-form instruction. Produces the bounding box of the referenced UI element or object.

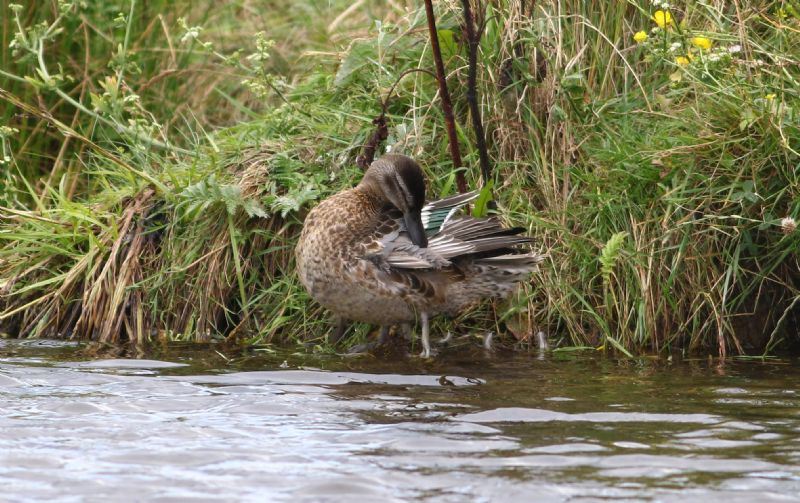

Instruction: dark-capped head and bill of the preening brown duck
[358,154,428,248]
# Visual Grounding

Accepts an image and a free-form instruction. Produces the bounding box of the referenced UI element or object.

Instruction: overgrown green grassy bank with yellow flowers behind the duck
[0,0,800,354]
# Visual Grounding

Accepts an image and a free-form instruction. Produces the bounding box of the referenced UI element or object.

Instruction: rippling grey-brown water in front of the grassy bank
[0,341,800,503]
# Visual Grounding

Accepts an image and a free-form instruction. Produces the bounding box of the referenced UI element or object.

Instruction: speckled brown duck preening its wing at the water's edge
[295,154,543,358]
